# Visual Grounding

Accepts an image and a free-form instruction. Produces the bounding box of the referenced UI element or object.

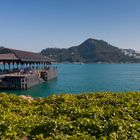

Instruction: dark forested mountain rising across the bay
[41,38,140,63]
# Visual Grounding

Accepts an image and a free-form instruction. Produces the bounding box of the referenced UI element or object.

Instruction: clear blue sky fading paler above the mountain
[0,0,140,51]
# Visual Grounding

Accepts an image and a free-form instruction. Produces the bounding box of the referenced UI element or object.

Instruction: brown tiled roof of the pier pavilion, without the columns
[0,48,54,62]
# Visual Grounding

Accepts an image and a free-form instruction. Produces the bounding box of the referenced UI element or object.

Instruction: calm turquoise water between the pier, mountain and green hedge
[1,64,140,97]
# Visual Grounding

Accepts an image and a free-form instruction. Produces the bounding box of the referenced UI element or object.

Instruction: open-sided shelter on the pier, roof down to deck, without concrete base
[0,48,55,74]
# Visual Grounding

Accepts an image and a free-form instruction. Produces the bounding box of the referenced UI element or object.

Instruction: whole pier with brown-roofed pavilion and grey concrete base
[0,48,57,90]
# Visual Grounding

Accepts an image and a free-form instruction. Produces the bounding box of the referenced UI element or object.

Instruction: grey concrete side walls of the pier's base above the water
[0,69,57,89]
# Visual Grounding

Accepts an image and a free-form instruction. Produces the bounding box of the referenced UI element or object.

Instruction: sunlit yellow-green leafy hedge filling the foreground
[0,92,140,140]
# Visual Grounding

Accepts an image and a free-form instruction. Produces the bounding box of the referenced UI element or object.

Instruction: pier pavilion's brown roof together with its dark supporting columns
[0,48,55,70]
